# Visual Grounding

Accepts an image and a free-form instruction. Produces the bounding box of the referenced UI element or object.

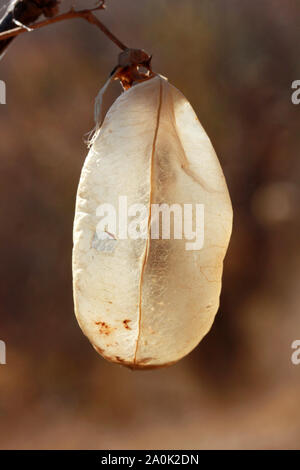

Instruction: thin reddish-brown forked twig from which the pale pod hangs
[0,3,128,51]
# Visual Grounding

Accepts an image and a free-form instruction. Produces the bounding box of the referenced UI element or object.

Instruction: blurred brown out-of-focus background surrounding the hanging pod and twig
[0,0,300,449]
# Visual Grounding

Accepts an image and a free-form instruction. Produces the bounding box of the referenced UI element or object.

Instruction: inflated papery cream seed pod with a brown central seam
[73,76,232,369]
